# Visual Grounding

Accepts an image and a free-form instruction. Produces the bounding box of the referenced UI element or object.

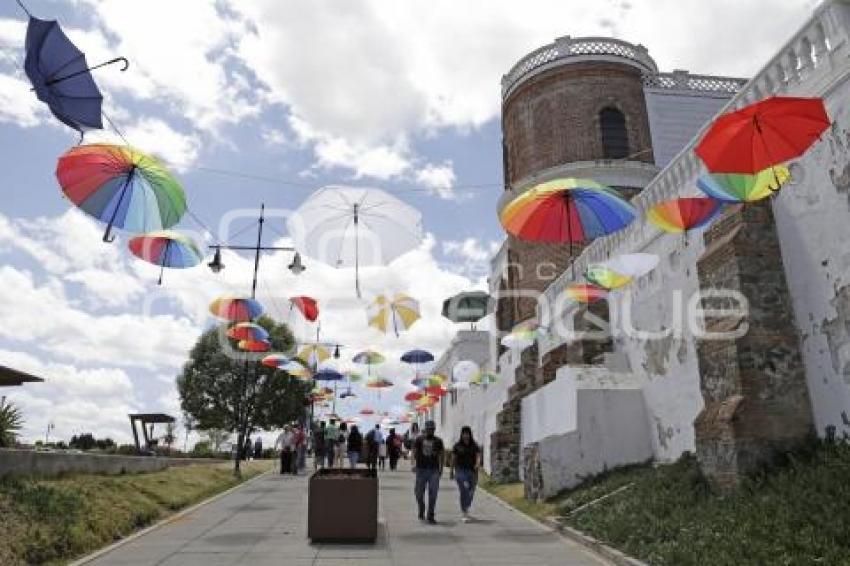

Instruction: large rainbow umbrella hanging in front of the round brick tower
[499,178,635,243]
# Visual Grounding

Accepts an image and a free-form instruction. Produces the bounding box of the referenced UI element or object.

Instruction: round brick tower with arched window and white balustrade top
[498,37,658,330]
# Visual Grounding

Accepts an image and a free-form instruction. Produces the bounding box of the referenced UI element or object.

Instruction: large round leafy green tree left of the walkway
[177,317,309,476]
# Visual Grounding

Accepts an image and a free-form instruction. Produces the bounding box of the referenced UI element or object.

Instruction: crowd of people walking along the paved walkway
[275,419,481,524]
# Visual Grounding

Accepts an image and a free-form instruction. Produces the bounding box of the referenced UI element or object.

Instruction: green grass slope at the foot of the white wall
[484,444,850,566]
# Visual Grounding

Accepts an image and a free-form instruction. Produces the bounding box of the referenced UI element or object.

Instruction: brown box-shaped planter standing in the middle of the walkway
[307,468,378,542]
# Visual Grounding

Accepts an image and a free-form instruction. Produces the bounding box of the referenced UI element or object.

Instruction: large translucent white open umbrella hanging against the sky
[288,186,422,297]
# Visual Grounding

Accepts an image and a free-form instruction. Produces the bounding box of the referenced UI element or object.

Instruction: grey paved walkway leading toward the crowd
[83,469,606,566]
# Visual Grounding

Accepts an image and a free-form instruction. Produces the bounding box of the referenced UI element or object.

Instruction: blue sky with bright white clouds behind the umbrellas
[0,0,817,452]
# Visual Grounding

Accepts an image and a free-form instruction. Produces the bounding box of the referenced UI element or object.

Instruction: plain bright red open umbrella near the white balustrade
[695,96,830,175]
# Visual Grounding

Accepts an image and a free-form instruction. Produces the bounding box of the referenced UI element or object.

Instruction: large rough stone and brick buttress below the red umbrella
[694,202,814,489]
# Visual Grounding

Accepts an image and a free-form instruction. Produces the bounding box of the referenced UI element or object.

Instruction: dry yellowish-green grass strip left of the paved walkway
[0,460,273,566]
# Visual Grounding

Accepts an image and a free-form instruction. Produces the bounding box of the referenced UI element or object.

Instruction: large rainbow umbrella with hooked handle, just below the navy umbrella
[56,144,186,242]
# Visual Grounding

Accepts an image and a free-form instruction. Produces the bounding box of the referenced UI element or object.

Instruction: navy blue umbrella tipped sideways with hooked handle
[19,11,130,135]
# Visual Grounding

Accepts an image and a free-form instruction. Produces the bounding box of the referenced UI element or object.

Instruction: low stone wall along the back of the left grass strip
[0,449,227,478]
